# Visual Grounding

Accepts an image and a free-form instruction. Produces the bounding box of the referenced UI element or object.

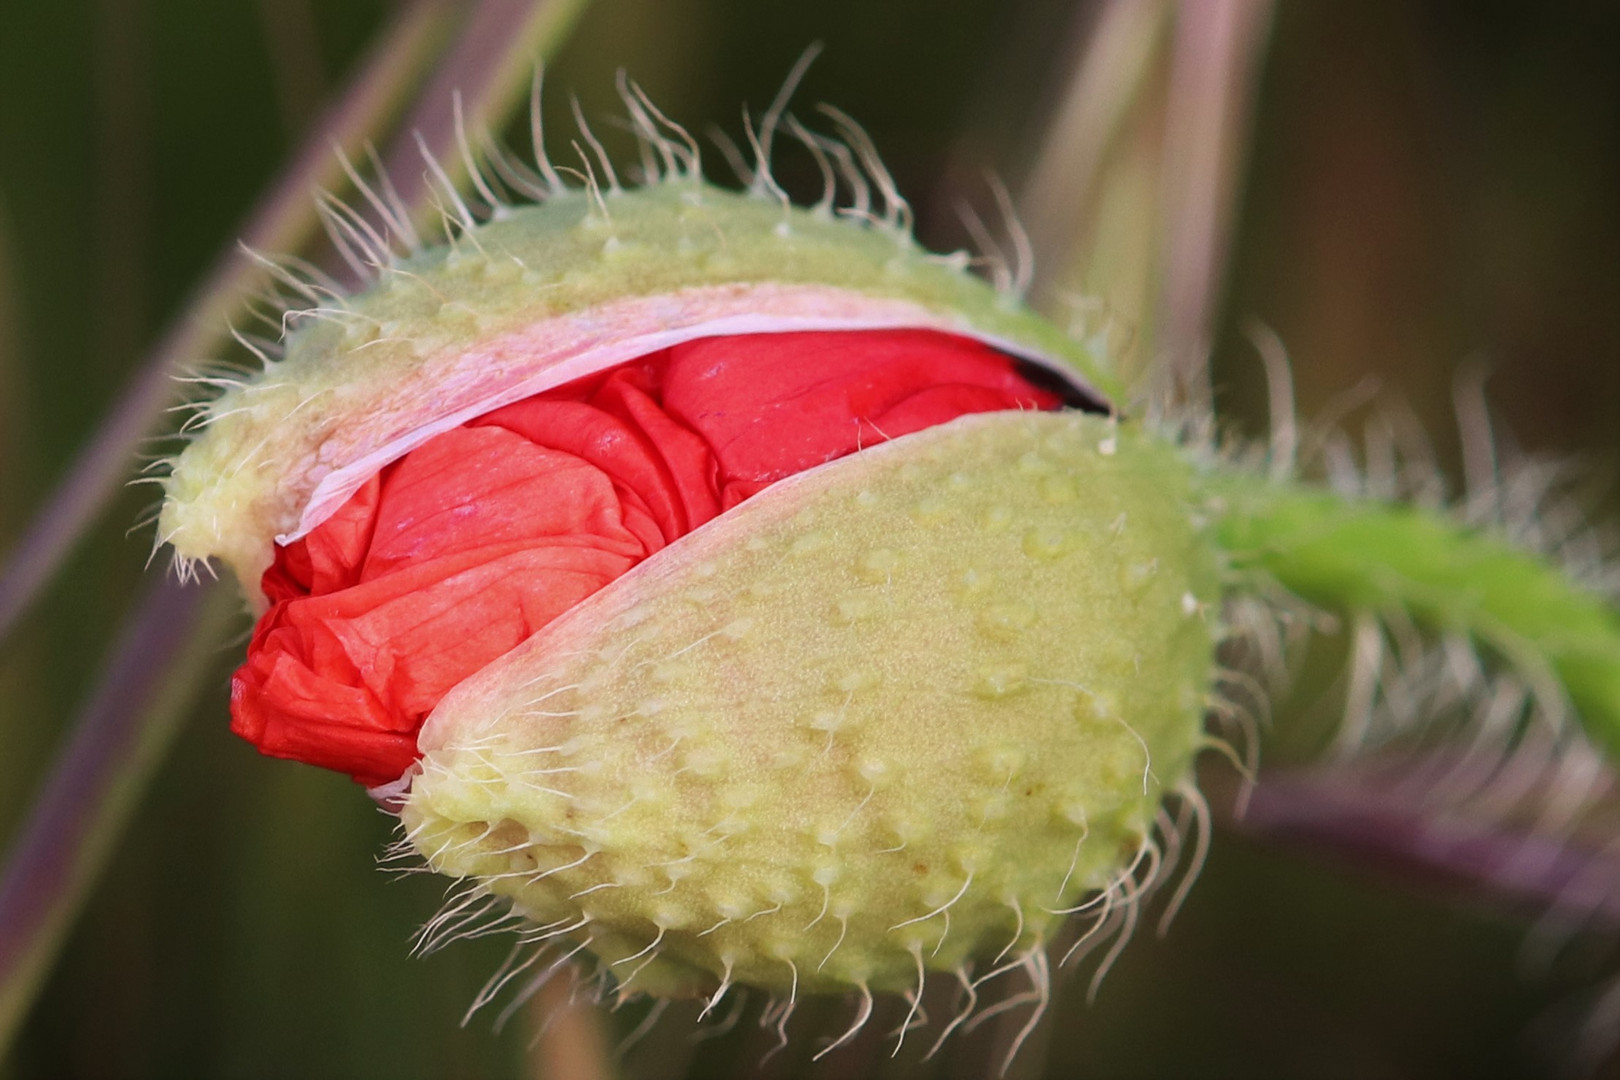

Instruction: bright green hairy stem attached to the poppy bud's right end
[1205,473,1620,751]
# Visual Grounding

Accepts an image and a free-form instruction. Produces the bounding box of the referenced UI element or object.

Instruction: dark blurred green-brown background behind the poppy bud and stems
[0,0,1620,1080]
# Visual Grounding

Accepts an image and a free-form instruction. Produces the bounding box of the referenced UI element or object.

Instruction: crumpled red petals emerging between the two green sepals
[232,330,1059,787]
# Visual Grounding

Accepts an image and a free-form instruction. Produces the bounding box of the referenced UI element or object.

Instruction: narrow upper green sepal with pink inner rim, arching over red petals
[159,181,1119,595]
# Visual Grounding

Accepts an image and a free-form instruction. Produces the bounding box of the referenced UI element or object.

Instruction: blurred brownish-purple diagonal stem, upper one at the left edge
[0,0,452,641]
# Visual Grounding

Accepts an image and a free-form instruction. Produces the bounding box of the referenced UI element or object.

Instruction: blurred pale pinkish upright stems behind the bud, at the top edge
[1019,0,1272,396]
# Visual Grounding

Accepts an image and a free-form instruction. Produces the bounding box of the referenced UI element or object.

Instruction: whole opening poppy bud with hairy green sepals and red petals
[160,153,1217,1023]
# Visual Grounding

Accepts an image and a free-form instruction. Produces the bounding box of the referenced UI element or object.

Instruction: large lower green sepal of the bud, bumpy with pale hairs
[402,413,1218,994]
